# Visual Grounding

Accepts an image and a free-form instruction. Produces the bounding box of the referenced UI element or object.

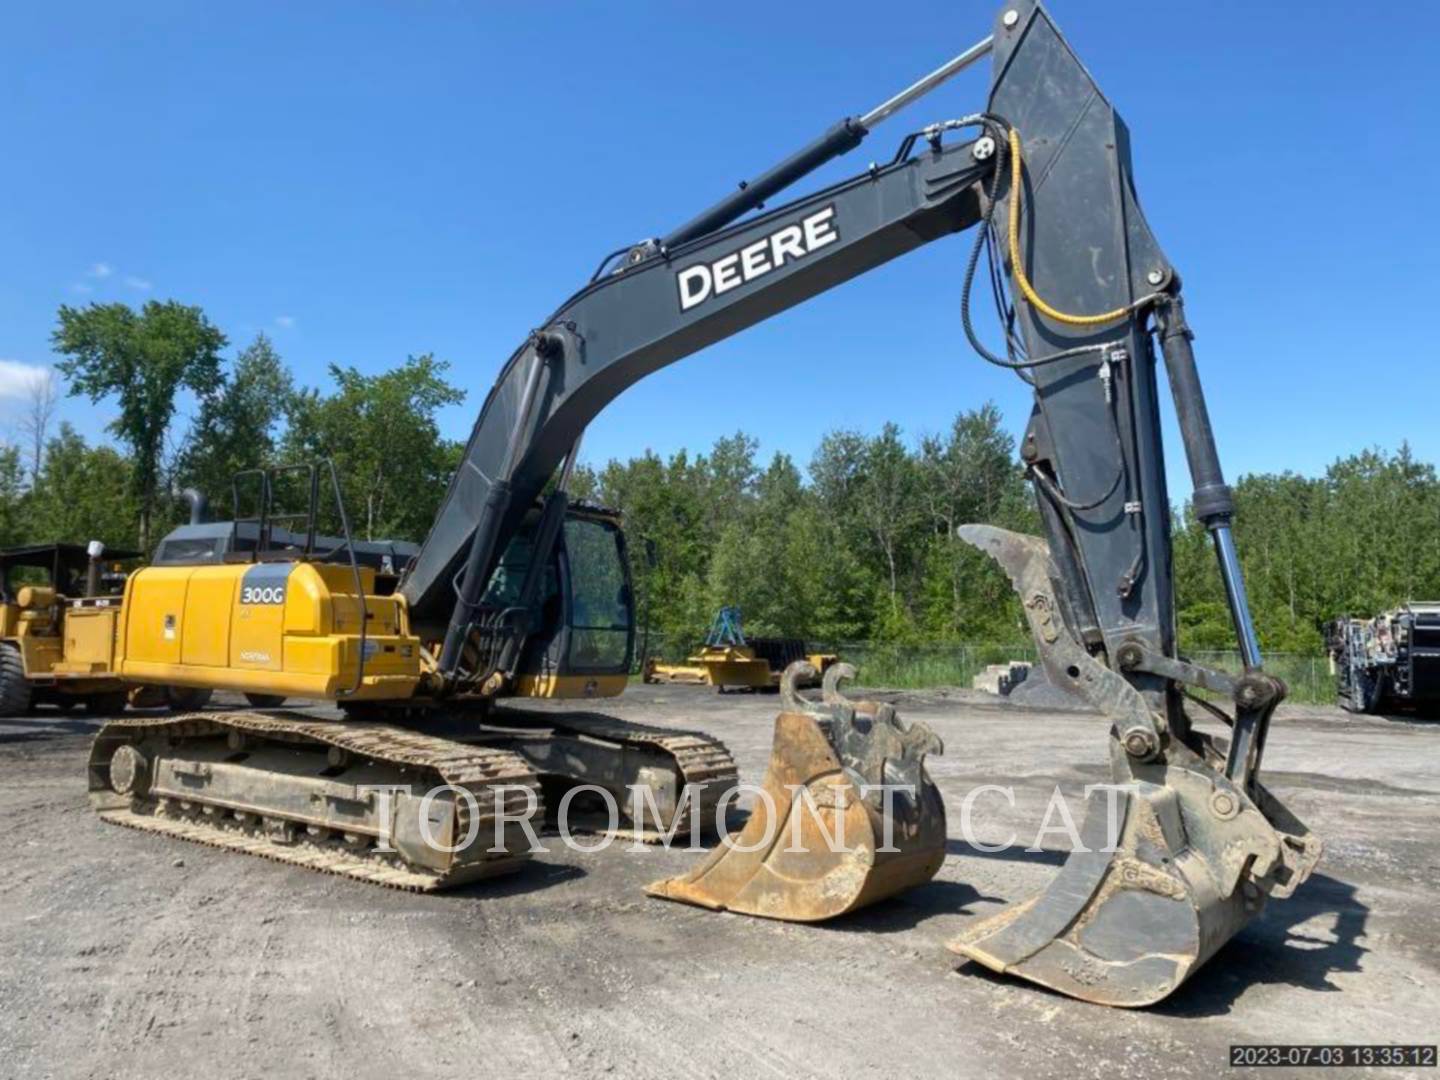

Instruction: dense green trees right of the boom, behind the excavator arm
[580,417,1440,654]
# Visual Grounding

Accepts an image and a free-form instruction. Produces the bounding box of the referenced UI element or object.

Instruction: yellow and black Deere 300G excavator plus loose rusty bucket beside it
[89,0,1320,1007]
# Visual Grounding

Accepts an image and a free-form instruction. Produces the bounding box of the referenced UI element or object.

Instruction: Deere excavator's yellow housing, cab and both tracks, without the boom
[88,504,737,891]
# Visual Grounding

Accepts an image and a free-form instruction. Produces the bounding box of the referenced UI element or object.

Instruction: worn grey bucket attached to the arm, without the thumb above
[950,768,1319,1007]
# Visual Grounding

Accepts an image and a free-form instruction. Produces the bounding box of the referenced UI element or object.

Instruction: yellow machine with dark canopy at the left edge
[0,541,140,716]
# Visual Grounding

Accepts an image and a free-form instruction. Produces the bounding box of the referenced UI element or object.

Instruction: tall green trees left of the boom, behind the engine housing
[0,301,465,553]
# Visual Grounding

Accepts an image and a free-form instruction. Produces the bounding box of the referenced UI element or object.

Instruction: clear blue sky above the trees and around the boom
[0,0,1440,495]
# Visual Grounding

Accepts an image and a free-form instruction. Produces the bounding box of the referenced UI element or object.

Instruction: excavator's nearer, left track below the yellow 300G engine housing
[89,711,543,893]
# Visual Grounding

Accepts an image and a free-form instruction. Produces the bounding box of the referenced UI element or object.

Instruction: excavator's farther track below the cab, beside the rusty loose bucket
[483,708,740,844]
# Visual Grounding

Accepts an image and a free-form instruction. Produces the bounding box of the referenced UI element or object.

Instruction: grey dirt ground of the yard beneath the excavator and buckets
[0,687,1440,1080]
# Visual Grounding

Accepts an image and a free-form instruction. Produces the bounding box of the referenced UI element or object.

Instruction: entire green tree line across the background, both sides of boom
[0,301,1440,652]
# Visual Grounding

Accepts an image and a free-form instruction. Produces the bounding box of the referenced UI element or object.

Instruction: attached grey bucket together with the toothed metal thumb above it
[950,526,1320,1007]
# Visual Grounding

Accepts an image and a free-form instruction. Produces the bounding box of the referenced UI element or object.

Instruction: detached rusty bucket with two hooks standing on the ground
[645,661,945,923]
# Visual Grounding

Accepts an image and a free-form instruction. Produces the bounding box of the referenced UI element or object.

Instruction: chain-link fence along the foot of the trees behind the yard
[635,634,1335,704]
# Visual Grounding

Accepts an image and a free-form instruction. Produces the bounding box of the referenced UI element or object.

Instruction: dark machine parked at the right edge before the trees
[1325,600,1440,713]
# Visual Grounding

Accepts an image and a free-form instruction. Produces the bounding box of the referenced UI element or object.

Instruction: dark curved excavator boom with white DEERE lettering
[400,126,989,642]
